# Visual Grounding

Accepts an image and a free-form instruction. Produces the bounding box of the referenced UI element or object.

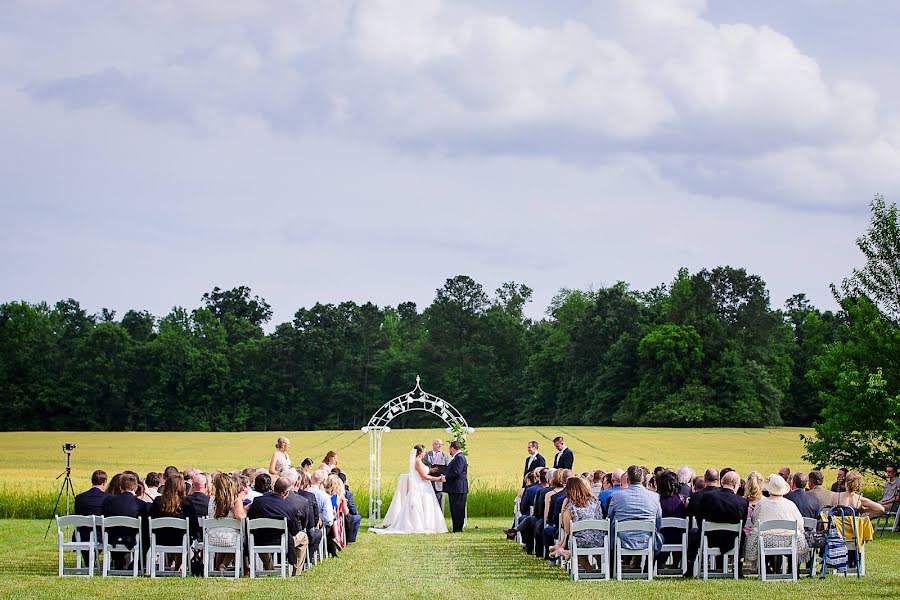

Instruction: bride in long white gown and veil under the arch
[372,444,447,533]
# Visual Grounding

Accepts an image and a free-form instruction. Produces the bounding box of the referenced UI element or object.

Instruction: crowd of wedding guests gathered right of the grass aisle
[506,438,900,577]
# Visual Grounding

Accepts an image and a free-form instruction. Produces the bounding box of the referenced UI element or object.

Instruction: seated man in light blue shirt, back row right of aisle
[608,465,662,568]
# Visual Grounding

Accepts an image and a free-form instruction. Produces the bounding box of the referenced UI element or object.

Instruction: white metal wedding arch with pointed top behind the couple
[362,375,475,527]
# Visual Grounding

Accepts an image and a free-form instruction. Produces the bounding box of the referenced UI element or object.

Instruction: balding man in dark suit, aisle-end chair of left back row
[247,475,309,575]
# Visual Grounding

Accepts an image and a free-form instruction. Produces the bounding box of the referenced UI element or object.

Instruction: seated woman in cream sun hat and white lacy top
[744,475,809,570]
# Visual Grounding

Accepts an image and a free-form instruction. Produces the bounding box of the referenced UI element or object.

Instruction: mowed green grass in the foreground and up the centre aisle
[0,519,900,600]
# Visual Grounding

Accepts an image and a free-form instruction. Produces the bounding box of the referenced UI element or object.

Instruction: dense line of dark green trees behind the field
[0,198,900,464]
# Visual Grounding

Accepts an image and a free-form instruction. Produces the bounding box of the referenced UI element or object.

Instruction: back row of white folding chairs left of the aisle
[56,515,327,578]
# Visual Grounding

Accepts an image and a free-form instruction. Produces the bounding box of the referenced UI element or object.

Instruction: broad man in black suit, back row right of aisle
[687,469,748,577]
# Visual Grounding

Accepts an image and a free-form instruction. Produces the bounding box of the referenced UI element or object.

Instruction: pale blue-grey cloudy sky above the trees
[0,0,900,323]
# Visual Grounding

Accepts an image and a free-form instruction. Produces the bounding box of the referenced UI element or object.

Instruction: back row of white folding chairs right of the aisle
[561,517,816,581]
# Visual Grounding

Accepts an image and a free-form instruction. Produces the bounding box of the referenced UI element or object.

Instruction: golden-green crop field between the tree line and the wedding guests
[0,427,860,517]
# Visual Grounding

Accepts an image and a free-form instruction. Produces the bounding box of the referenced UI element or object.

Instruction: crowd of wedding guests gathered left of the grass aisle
[74,437,362,574]
